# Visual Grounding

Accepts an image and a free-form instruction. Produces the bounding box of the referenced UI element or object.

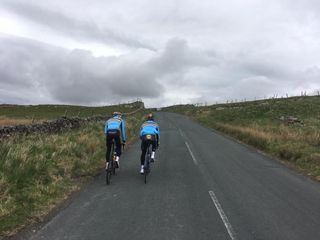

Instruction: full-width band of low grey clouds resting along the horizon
[0,28,320,106]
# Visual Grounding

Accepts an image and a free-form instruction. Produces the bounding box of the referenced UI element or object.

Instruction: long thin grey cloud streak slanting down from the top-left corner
[0,0,154,50]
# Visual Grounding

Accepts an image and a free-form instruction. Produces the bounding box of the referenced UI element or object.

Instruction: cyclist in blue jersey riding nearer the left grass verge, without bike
[104,112,126,170]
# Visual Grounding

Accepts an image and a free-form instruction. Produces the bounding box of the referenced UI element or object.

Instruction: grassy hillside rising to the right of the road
[166,96,320,180]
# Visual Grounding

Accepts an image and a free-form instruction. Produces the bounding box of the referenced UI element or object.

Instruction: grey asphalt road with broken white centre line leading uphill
[17,113,320,240]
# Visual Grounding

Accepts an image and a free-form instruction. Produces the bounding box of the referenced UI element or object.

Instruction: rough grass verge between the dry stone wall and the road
[0,109,145,238]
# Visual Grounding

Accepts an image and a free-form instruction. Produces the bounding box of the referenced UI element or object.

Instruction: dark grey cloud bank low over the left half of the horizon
[0,36,162,104]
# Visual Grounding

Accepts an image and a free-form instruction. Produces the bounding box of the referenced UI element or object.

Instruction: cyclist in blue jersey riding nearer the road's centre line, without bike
[140,113,160,174]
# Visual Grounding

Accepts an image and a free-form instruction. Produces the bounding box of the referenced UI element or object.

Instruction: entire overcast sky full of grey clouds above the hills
[0,0,320,106]
